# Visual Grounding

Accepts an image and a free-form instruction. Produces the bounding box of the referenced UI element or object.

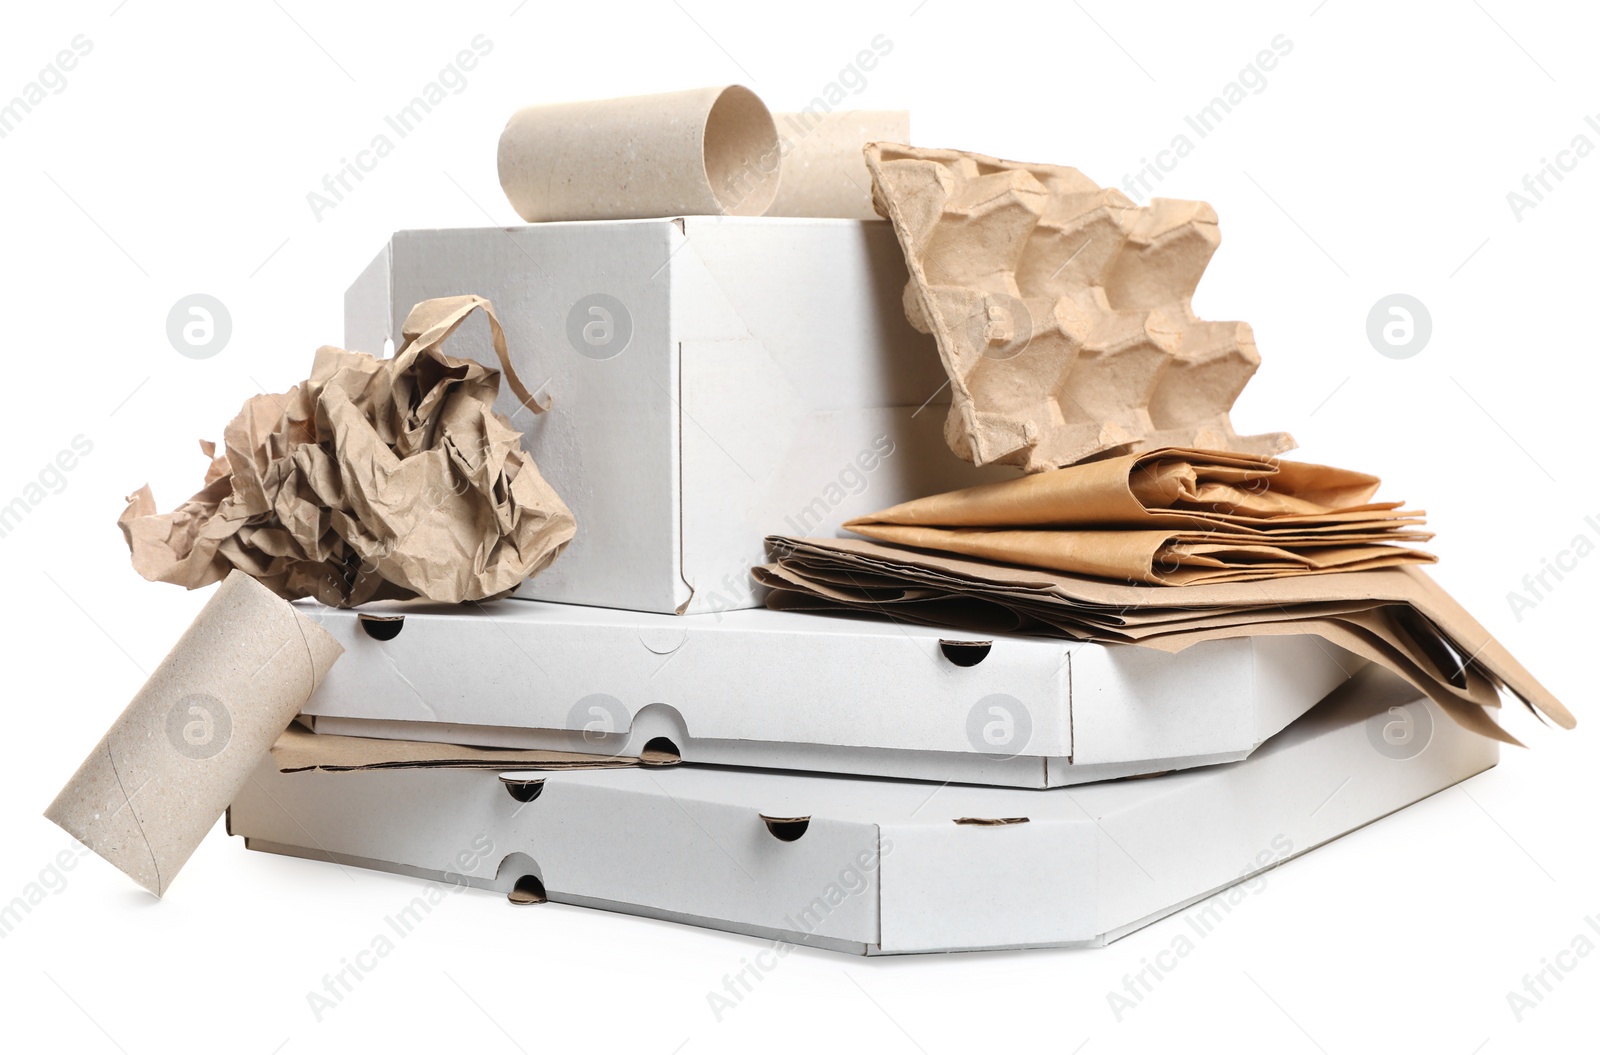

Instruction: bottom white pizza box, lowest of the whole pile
[229,668,1498,965]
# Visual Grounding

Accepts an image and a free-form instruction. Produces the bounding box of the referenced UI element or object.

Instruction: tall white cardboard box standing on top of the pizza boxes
[346,216,1014,612]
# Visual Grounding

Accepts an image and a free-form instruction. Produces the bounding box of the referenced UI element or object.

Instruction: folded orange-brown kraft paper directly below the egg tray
[845,448,1434,586]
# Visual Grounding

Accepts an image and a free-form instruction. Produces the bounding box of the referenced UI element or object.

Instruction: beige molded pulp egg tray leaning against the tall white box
[866,142,1294,472]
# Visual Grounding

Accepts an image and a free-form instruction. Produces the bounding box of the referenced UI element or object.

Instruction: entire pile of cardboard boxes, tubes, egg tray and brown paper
[48,86,1573,954]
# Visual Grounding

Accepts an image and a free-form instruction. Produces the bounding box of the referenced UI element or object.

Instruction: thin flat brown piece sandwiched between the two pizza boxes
[272,722,677,773]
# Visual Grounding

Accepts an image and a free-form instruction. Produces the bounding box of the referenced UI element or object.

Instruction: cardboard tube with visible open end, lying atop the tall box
[499,85,781,223]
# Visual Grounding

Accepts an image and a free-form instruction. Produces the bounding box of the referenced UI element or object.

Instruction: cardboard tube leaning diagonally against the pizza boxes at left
[45,572,344,897]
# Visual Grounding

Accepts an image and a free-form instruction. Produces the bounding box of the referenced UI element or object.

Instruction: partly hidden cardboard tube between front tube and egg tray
[766,110,910,219]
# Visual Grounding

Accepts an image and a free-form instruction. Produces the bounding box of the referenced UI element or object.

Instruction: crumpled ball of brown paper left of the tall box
[117,296,576,607]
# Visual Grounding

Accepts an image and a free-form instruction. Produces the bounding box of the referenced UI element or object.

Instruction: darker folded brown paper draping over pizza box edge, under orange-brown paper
[754,536,1576,743]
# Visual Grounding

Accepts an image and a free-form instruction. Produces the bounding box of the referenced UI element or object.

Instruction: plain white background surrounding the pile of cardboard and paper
[0,0,1600,1055]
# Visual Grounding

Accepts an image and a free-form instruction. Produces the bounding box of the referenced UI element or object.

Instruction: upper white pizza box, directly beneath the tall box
[294,600,1362,788]
